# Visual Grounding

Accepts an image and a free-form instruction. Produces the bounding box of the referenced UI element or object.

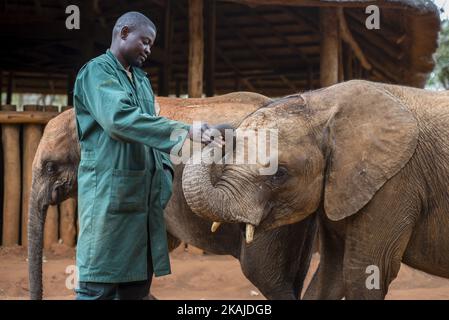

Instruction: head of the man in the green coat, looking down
[111,11,156,68]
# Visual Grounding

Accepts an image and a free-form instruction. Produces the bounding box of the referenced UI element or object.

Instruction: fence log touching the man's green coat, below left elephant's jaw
[59,106,76,247]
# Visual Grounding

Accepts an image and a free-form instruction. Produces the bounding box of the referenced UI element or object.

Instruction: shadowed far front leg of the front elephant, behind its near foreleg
[303,214,345,300]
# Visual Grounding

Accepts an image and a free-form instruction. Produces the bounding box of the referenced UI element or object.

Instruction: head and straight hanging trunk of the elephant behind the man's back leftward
[28,109,80,299]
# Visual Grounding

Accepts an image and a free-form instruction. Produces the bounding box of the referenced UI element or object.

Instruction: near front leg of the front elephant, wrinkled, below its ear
[343,176,421,299]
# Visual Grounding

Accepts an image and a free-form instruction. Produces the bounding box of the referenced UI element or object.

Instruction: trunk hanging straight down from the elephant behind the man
[28,178,48,300]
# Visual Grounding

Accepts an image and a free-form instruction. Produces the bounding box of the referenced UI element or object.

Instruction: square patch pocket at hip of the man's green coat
[111,169,148,213]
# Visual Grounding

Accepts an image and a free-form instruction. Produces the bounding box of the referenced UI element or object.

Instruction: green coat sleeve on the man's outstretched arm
[77,63,190,153]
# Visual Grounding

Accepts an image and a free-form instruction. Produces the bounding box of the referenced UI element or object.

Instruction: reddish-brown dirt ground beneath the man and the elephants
[0,245,449,300]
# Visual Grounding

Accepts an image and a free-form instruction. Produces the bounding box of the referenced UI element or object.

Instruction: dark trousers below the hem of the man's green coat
[75,246,153,300]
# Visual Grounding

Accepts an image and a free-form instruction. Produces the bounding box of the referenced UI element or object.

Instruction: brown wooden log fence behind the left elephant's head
[0,105,77,249]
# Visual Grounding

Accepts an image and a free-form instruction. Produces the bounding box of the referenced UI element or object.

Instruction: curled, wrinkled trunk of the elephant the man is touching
[182,150,265,240]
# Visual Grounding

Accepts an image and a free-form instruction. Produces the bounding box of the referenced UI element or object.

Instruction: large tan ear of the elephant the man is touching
[308,81,418,221]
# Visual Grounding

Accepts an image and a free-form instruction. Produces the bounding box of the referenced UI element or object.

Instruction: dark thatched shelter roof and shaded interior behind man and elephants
[0,0,440,96]
